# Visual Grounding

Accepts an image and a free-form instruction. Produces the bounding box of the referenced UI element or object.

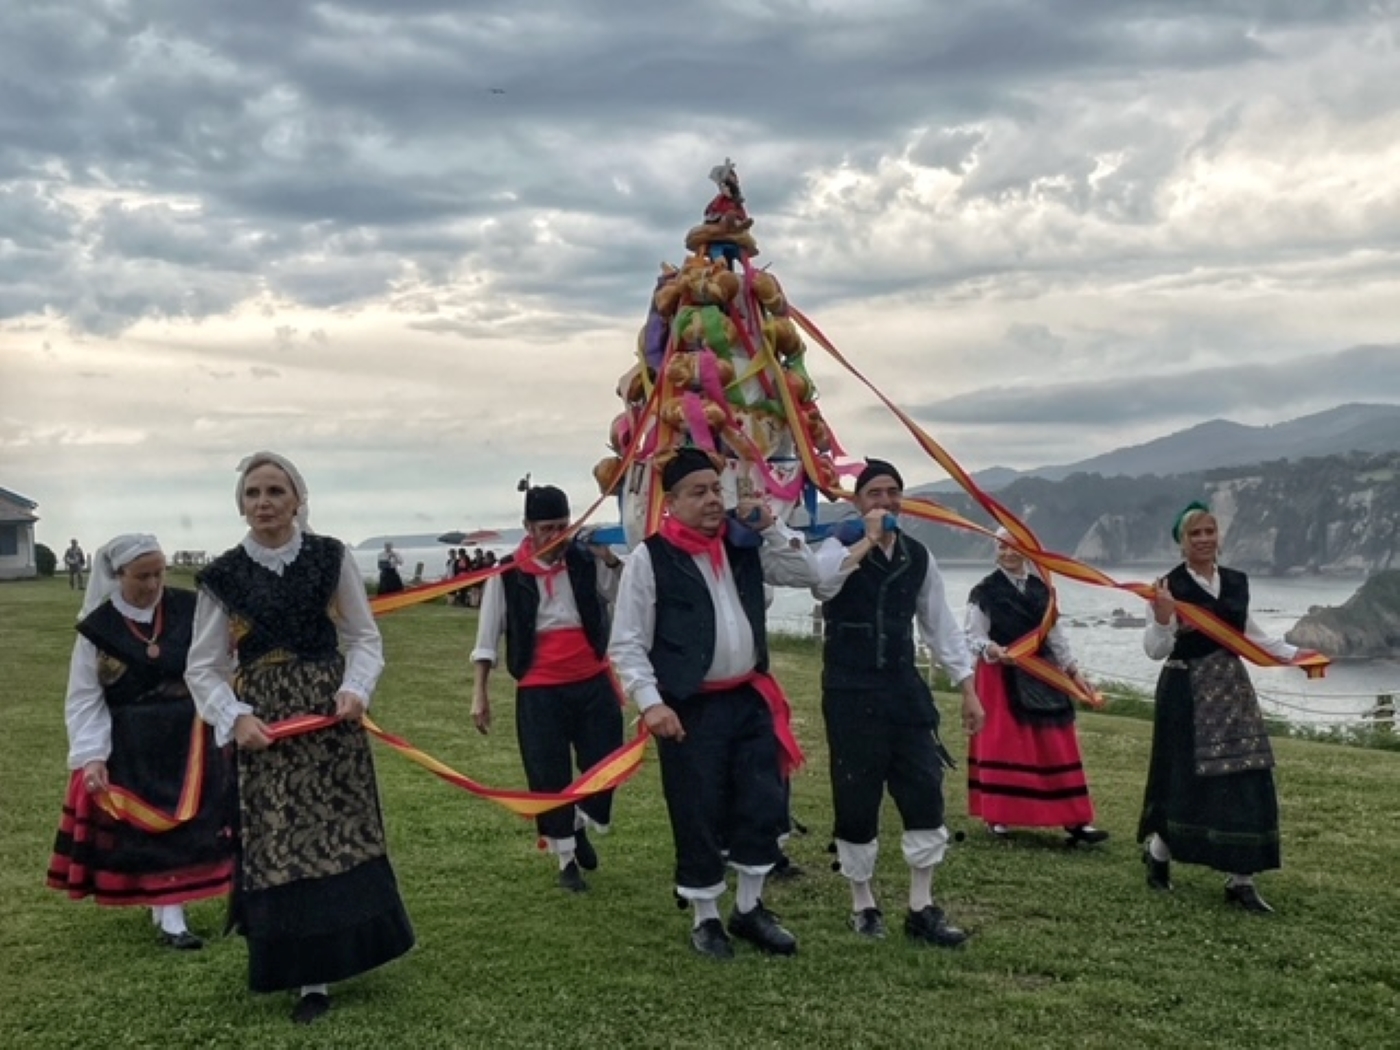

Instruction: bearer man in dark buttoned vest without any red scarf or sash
[812,459,983,948]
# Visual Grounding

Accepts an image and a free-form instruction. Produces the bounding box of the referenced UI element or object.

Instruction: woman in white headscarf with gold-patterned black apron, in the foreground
[186,452,413,1023]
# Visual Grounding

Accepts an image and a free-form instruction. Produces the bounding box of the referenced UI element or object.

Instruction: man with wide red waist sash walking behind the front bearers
[472,484,623,893]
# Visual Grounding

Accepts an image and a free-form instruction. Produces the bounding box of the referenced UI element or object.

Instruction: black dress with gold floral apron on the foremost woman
[199,535,413,991]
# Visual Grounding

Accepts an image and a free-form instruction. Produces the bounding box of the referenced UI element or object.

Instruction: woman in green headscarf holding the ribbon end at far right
[1138,501,1299,913]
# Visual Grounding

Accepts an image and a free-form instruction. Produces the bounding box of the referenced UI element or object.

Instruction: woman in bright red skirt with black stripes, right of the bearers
[965,529,1109,846]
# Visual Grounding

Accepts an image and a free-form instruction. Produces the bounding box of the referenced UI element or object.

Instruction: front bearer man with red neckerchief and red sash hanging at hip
[608,448,818,959]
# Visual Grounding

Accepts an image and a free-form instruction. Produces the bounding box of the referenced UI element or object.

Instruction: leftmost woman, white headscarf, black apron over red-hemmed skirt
[48,533,232,951]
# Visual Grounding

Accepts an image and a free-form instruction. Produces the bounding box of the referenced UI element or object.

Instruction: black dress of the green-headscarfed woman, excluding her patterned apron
[1138,566,1280,875]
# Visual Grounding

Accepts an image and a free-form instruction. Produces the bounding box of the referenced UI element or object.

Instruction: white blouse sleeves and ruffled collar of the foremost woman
[185,529,384,745]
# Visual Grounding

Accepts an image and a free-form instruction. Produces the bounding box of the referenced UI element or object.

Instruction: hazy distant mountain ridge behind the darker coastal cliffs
[931,405,1400,491]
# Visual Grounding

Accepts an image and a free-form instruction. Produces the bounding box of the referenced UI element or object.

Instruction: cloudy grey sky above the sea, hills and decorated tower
[0,0,1400,549]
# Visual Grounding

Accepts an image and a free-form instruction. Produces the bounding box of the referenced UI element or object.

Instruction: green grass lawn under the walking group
[0,581,1400,1049]
